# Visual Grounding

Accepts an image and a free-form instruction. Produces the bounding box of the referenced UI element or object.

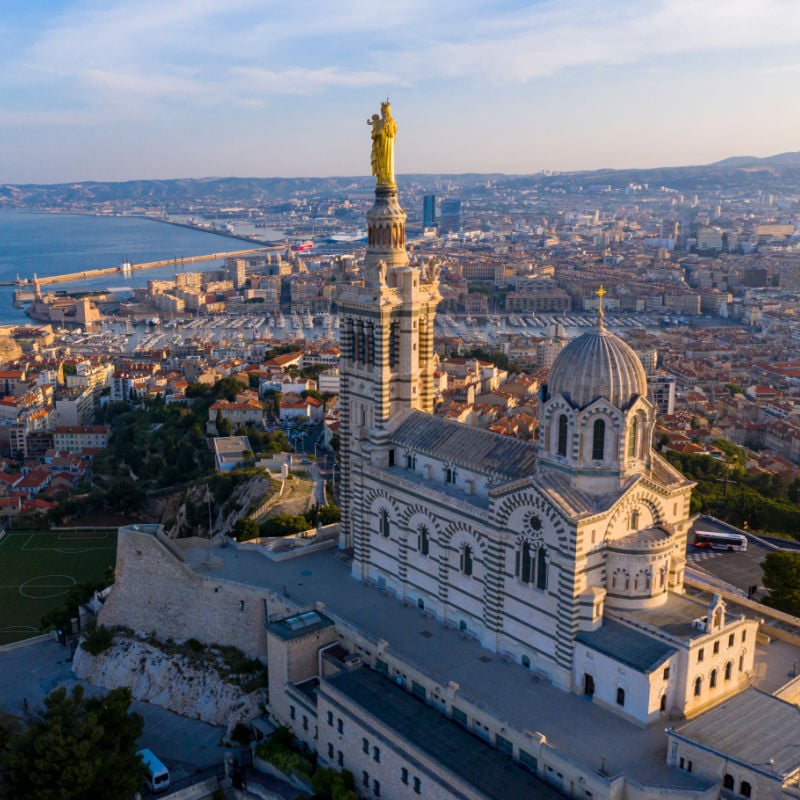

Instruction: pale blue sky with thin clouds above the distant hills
[0,0,800,183]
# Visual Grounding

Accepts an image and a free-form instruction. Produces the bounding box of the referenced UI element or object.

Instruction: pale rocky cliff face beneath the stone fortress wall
[72,638,267,734]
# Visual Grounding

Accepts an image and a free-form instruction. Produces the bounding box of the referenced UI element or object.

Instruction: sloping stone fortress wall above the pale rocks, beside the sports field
[99,528,275,658]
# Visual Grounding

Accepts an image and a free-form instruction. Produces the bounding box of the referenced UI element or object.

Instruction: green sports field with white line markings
[0,528,117,645]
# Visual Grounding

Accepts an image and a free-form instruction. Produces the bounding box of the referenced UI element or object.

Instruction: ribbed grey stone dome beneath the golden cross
[547,318,647,410]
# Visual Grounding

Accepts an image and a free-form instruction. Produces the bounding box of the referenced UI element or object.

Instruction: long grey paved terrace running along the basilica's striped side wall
[186,546,707,788]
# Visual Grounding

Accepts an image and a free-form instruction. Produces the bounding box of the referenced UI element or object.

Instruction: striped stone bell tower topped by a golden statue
[336,100,441,547]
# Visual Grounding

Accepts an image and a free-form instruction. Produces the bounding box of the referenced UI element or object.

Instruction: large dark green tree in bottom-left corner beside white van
[2,686,145,800]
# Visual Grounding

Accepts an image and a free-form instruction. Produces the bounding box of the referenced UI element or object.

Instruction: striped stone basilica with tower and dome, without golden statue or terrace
[337,101,757,724]
